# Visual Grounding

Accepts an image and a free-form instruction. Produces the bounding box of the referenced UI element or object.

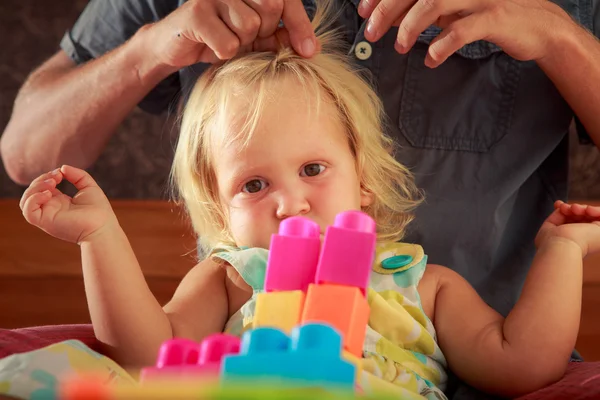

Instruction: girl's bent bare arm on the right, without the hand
[426,237,582,397]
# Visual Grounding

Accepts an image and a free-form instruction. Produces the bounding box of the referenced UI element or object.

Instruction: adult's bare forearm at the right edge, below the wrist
[538,21,600,146]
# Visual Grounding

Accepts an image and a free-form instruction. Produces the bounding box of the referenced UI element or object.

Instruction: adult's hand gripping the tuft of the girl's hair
[143,0,317,69]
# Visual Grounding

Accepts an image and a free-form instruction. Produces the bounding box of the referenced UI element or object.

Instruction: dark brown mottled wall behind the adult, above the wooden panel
[0,0,600,199]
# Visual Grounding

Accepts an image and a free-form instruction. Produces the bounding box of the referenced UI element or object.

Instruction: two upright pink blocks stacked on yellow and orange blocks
[253,211,376,357]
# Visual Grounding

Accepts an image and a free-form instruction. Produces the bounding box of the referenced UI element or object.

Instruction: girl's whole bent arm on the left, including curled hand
[20,166,228,367]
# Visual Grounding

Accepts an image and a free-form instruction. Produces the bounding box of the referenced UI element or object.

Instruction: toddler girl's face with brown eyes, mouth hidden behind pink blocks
[213,79,371,248]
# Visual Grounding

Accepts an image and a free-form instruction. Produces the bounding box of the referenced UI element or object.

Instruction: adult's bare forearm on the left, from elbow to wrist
[0,28,174,184]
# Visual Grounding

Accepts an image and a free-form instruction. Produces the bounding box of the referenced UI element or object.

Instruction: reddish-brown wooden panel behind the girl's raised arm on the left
[0,199,196,328]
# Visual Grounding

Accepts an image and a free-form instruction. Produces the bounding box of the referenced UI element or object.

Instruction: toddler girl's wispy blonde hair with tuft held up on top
[171,1,421,250]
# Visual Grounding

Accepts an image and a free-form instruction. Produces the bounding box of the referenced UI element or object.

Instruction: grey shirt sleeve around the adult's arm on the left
[60,0,180,114]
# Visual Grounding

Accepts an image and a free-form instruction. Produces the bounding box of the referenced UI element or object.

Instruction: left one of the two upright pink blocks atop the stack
[265,217,321,292]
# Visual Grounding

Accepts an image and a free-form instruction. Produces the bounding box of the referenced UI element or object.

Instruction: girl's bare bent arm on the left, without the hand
[81,234,228,367]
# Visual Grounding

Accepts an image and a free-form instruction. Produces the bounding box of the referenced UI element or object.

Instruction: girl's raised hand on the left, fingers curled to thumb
[19,165,118,243]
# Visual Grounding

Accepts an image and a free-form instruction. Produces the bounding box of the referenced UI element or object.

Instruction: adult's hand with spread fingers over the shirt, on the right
[358,0,573,67]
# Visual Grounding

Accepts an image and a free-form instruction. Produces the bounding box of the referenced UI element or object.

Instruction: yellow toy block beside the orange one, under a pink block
[252,290,306,334]
